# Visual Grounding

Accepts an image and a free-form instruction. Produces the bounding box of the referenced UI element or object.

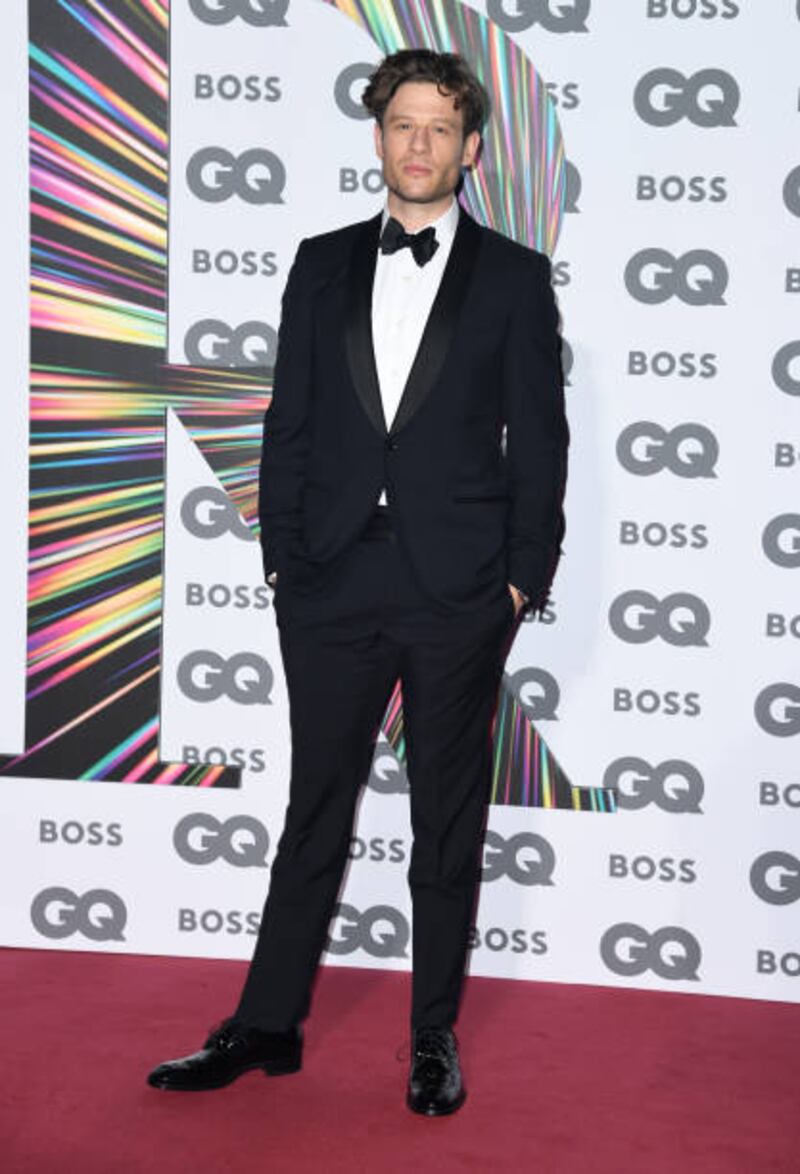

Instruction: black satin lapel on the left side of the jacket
[345,214,386,436]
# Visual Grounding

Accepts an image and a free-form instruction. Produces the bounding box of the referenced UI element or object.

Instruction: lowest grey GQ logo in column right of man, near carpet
[600,922,702,983]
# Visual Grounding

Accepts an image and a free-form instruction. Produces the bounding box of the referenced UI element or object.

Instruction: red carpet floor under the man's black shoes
[0,950,800,1174]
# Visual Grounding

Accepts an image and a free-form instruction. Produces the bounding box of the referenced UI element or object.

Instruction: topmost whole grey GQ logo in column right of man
[633,67,741,129]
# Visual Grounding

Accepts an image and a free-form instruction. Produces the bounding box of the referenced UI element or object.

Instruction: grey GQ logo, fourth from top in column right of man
[609,591,711,648]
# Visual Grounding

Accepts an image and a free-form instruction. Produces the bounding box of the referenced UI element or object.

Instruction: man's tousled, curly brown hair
[361,49,490,137]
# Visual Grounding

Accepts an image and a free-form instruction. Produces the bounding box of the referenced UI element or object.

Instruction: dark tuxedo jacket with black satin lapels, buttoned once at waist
[260,209,569,609]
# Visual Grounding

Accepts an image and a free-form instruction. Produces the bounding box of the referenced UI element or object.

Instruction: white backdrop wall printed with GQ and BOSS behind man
[0,0,800,1000]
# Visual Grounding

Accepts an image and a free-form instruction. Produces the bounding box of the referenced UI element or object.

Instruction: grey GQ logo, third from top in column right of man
[617,420,719,480]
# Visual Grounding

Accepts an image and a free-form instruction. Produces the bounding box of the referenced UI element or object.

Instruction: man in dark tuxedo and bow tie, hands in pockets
[148,49,567,1115]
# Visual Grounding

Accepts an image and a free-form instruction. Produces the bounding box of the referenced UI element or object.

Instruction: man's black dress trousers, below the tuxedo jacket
[236,510,515,1031]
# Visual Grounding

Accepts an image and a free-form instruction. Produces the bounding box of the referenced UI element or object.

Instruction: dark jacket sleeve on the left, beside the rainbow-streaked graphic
[258,241,312,578]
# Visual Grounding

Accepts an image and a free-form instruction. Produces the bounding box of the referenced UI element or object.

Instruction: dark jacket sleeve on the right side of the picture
[503,252,570,609]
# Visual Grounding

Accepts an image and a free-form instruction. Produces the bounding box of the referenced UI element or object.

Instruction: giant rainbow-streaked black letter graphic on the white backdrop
[0,0,609,810]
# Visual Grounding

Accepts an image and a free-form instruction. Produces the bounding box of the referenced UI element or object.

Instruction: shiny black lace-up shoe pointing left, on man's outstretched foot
[147,1019,303,1092]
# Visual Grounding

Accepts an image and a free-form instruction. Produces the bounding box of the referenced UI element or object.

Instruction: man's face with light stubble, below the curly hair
[375,81,480,204]
